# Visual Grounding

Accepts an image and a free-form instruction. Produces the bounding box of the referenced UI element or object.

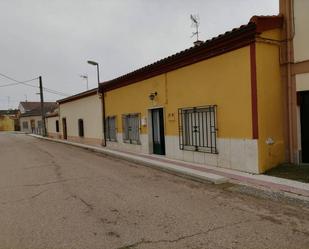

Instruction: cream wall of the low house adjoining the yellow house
[59,94,103,145]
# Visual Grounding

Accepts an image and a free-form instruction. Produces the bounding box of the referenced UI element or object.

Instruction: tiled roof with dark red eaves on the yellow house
[99,16,283,92]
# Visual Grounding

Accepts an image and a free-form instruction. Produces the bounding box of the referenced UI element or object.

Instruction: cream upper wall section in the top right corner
[293,0,309,62]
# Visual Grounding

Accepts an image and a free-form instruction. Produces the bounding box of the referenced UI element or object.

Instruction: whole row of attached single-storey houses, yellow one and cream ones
[46,0,309,173]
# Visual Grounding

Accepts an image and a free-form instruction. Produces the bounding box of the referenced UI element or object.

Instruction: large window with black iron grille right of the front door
[178,105,217,154]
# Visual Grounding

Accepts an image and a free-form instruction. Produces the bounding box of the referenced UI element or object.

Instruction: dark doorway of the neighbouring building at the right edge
[300,91,309,163]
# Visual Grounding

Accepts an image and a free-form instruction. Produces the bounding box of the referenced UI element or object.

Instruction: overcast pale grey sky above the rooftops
[0,0,279,109]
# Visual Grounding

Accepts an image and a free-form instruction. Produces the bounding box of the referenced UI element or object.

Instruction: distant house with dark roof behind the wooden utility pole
[18,102,58,134]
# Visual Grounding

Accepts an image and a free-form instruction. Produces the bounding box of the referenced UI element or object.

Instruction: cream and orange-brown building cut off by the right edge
[280,0,309,163]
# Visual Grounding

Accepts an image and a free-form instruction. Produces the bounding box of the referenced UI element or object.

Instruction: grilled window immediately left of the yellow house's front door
[122,114,140,144]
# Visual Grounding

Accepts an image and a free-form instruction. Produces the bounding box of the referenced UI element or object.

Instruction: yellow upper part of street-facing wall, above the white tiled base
[105,46,252,138]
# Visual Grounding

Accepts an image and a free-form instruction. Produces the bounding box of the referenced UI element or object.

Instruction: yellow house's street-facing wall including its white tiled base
[105,46,260,173]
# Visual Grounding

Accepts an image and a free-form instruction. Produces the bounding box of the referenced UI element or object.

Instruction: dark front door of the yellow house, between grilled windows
[151,108,165,155]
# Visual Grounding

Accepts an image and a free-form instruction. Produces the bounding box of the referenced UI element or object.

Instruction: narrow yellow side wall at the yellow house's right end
[256,37,285,172]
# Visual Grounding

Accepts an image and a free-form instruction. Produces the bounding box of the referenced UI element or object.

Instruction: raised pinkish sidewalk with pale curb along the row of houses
[27,134,309,204]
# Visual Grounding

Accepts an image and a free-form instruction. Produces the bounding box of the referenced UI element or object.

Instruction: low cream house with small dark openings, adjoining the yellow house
[54,88,103,145]
